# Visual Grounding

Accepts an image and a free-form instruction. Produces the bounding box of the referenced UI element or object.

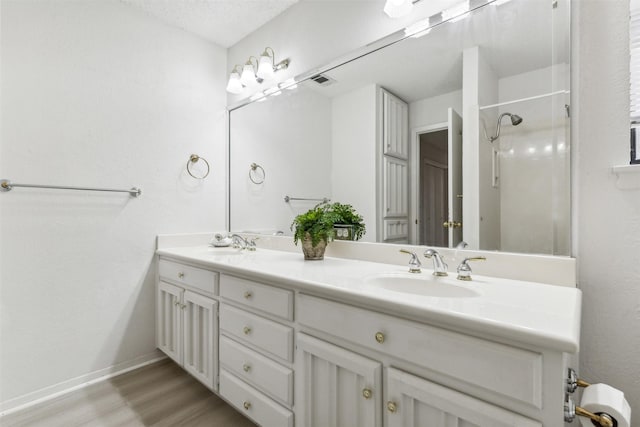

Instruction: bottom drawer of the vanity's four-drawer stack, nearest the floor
[220,369,293,427]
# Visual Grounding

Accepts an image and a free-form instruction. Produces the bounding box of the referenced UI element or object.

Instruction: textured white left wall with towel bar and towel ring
[0,0,226,410]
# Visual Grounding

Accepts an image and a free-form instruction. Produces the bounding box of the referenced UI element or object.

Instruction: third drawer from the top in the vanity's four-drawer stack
[220,336,293,406]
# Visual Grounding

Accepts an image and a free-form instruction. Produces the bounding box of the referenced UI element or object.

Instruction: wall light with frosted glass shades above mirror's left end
[227,47,289,95]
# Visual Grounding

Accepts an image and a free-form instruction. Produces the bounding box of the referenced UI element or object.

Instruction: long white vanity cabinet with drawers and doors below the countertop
[157,254,571,427]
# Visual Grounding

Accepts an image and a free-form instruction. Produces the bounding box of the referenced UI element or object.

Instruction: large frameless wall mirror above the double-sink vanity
[229,0,571,256]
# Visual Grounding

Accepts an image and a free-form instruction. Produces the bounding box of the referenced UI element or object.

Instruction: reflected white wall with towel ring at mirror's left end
[230,87,332,234]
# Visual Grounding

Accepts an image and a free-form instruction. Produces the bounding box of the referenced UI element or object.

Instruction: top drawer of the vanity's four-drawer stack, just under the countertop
[220,274,293,320]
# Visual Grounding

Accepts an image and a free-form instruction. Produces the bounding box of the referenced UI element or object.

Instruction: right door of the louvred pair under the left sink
[182,291,218,390]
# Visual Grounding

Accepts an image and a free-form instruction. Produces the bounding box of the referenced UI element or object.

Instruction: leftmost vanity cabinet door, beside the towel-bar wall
[156,282,184,364]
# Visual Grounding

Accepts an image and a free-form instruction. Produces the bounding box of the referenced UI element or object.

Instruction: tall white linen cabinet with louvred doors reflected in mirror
[378,88,409,243]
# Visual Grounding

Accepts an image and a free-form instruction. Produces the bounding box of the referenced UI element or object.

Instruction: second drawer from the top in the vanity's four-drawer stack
[220,304,293,362]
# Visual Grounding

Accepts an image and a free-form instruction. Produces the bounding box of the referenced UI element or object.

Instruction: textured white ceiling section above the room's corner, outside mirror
[120,0,298,48]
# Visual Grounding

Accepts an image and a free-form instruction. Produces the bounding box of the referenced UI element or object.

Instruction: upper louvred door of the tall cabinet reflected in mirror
[382,90,409,159]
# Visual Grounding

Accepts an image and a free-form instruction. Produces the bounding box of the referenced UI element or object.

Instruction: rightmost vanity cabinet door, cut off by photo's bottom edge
[385,368,542,427]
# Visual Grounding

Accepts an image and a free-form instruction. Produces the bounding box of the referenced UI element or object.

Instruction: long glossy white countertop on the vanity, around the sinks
[157,245,582,353]
